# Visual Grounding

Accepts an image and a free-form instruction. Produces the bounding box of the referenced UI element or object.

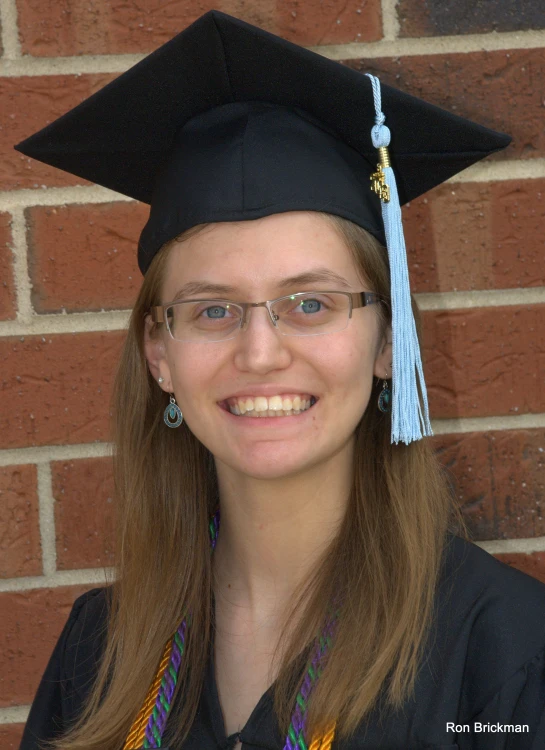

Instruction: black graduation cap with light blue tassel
[15,10,511,444]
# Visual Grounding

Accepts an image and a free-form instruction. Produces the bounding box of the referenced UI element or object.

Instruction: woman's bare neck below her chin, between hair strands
[213,445,353,624]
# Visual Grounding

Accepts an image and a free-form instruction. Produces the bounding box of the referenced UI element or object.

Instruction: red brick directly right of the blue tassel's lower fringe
[423,305,545,419]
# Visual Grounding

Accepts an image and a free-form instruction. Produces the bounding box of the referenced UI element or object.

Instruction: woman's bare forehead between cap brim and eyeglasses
[163,211,358,299]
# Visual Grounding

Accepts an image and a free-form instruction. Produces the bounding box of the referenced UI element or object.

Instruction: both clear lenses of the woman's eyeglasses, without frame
[166,292,350,341]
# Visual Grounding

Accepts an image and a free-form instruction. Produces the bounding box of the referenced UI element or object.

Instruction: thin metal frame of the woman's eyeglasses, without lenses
[149,289,389,344]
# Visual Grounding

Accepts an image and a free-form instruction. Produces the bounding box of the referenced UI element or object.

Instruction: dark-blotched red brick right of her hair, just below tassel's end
[433,430,545,541]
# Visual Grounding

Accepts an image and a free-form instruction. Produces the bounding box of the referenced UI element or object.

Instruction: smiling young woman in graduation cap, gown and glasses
[18,11,545,750]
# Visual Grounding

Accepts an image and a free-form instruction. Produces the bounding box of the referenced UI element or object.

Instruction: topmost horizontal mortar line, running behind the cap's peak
[0,27,545,78]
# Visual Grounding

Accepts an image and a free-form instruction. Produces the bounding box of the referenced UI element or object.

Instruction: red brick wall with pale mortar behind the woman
[0,0,545,748]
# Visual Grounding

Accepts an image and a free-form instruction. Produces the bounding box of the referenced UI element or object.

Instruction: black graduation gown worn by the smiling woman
[20,535,545,750]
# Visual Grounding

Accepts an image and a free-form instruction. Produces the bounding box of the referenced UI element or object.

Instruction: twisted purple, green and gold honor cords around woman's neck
[123,506,339,750]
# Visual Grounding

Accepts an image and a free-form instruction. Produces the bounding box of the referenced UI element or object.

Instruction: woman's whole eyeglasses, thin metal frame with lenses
[150,292,384,343]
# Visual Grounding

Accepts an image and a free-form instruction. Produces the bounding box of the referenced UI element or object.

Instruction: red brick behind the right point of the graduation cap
[346,49,545,167]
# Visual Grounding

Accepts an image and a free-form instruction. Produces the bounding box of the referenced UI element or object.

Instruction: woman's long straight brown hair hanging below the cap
[52,214,469,750]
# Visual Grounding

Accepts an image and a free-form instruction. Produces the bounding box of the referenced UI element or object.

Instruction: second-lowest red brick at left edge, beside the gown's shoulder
[0,585,94,706]
